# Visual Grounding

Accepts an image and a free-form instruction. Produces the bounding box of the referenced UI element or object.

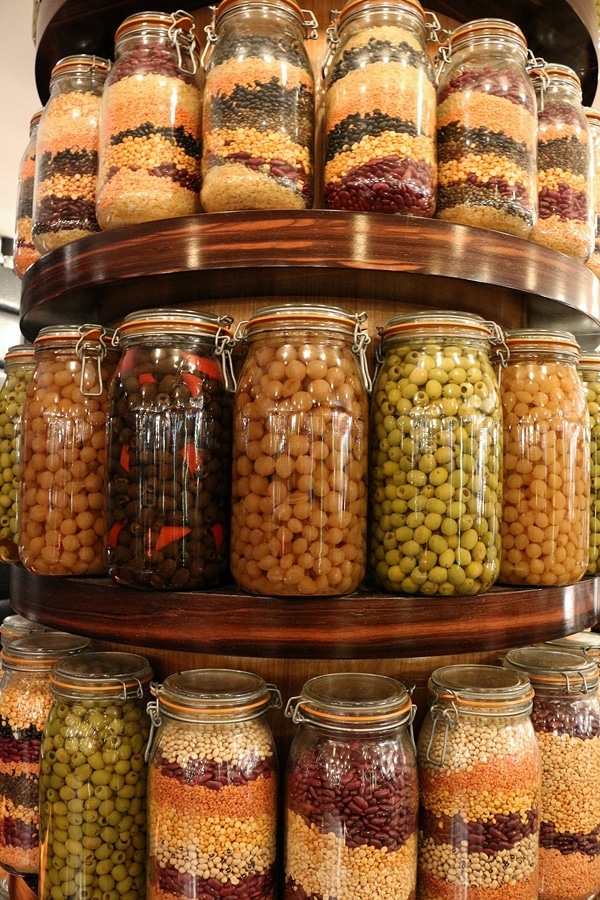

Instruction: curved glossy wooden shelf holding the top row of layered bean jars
[21,210,600,348]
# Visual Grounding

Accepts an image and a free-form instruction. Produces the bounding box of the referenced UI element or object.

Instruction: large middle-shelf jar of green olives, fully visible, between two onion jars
[369,311,502,596]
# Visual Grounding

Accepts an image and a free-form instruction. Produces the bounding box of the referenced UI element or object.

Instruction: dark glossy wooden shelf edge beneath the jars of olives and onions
[11,566,600,659]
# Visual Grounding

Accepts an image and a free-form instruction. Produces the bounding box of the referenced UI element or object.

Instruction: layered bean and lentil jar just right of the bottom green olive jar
[148,669,281,900]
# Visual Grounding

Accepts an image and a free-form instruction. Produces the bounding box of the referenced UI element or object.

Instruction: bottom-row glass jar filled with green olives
[38,651,152,900]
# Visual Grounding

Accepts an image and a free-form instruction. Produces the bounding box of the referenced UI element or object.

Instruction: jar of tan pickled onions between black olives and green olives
[231,303,369,596]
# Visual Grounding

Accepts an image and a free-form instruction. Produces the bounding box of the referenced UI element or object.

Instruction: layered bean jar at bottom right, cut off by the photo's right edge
[504,646,600,900]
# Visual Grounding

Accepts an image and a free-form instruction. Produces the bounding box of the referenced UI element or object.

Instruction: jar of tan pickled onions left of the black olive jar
[19,325,116,575]
